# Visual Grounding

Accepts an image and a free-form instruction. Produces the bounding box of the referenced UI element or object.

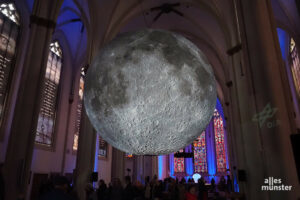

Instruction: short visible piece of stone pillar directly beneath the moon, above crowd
[111,147,125,183]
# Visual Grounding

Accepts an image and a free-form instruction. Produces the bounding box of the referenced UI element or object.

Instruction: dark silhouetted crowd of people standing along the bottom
[35,176,240,200]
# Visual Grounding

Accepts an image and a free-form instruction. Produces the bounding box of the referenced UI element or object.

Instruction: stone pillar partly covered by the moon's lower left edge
[75,106,97,200]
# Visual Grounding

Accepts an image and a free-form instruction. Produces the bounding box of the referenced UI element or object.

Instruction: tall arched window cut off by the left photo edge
[0,3,20,123]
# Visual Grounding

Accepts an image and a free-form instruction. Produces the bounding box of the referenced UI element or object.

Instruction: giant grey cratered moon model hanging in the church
[84,29,217,155]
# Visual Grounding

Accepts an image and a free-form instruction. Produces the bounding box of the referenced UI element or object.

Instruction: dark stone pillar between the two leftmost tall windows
[4,0,63,199]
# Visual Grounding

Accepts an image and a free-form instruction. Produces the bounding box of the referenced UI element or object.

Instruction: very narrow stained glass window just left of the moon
[73,68,84,151]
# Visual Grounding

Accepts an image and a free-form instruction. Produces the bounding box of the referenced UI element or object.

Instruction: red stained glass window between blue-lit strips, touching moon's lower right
[193,132,207,173]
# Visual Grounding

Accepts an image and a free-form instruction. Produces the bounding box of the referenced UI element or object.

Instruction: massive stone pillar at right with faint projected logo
[232,0,300,200]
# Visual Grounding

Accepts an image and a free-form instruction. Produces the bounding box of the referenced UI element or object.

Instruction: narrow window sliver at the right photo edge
[290,38,300,96]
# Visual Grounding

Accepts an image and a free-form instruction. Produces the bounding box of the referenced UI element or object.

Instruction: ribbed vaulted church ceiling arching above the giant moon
[21,0,300,100]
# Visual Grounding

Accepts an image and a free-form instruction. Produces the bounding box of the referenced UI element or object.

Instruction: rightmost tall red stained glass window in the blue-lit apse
[213,109,226,172]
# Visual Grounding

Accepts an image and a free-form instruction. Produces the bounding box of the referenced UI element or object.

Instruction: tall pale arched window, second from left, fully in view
[35,41,62,146]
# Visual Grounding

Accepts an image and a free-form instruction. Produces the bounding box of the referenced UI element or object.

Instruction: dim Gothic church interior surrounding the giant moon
[0,0,300,200]
